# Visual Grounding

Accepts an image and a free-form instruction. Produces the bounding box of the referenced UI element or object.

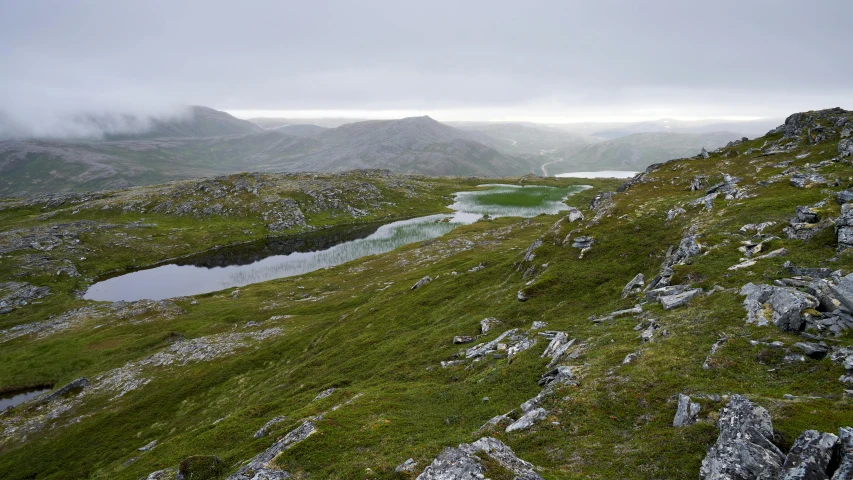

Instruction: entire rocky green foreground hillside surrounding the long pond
[0,109,853,480]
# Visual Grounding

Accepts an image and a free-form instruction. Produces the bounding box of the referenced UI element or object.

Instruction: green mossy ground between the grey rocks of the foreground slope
[0,129,853,479]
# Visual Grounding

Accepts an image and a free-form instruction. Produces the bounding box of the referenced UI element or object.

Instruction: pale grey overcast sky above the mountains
[0,0,853,129]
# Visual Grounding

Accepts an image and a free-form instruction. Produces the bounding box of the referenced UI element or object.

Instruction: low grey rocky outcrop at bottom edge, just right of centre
[418,437,542,480]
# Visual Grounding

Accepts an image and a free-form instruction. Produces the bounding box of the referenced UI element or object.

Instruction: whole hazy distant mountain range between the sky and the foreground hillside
[0,106,760,195]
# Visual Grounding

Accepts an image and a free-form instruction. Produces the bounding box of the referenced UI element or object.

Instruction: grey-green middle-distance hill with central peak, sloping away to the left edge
[0,110,531,196]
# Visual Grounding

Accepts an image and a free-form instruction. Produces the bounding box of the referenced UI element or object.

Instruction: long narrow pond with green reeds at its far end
[84,184,589,301]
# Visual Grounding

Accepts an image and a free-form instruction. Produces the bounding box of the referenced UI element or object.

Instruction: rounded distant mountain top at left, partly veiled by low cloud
[104,106,263,140]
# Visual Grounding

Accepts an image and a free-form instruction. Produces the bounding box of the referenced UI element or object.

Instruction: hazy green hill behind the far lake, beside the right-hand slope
[547,132,743,174]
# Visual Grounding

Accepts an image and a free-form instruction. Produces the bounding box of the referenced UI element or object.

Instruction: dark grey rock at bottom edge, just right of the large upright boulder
[779,430,838,480]
